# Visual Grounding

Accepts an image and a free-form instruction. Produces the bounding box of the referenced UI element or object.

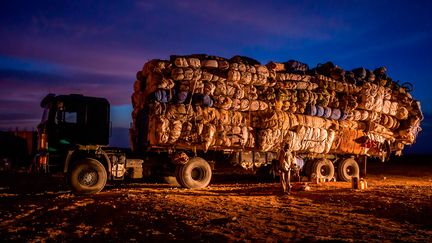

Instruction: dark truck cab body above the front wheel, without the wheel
[38,94,110,172]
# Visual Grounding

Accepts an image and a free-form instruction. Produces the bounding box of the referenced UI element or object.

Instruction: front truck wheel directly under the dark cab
[69,158,107,194]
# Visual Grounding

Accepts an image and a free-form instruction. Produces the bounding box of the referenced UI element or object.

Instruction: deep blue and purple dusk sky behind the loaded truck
[0,0,432,152]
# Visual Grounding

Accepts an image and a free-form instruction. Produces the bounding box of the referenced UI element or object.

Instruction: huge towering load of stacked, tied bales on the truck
[131,55,422,159]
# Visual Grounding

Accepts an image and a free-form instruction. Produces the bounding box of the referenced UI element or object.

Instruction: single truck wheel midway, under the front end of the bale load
[176,157,212,189]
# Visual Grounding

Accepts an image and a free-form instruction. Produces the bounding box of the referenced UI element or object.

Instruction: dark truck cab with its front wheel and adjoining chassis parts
[34,94,142,194]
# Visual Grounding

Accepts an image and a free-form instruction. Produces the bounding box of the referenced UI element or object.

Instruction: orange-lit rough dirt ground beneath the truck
[0,160,432,242]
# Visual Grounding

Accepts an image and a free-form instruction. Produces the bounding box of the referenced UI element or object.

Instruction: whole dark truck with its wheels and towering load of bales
[34,54,423,194]
